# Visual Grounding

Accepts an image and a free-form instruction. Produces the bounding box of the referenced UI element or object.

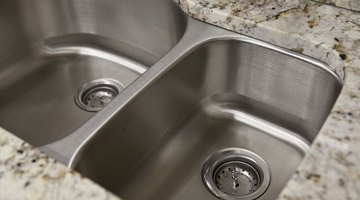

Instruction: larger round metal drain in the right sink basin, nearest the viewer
[202,148,270,200]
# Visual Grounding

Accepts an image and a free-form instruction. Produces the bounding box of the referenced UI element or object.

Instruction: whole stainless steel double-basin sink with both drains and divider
[0,0,342,200]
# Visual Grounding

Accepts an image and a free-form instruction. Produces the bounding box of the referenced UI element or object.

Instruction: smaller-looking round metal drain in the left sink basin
[75,78,124,112]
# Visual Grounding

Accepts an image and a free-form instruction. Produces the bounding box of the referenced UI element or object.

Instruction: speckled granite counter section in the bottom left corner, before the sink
[0,128,119,200]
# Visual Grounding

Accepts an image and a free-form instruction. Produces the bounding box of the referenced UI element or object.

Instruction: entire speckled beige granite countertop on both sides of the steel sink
[0,0,360,200]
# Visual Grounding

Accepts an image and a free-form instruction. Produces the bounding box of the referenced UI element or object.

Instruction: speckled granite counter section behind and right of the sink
[179,0,360,200]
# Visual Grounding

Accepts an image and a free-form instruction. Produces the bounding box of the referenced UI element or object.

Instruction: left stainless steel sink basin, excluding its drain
[0,0,187,146]
